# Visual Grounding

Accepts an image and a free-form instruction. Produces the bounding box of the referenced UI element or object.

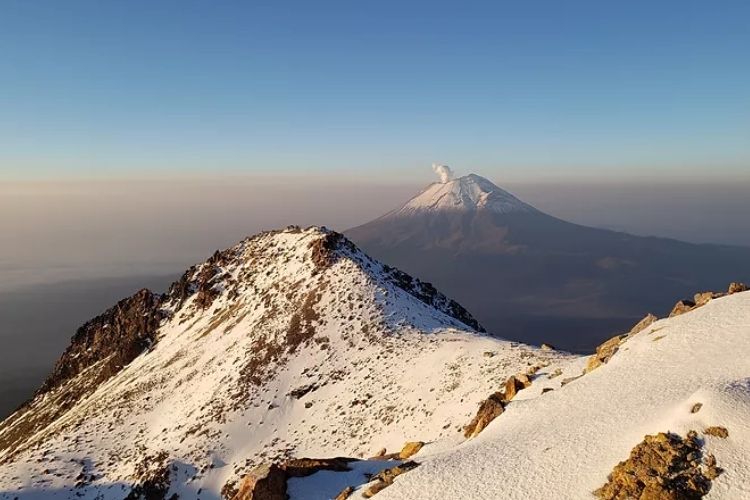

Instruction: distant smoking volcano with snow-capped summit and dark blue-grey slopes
[346,174,750,352]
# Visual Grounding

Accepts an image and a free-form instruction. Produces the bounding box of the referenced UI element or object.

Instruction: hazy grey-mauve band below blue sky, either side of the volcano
[0,174,750,290]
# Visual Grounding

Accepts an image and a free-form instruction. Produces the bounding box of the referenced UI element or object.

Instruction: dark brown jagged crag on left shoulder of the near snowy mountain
[38,289,163,394]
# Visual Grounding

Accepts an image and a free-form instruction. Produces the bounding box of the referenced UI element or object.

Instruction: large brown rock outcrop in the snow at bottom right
[594,431,721,500]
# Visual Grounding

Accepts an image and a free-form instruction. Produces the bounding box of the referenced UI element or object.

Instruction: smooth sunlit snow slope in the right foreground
[378,292,750,500]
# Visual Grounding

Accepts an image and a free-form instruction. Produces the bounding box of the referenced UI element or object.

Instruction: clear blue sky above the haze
[0,0,750,179]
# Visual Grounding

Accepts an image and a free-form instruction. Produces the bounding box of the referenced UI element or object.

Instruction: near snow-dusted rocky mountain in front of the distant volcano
[0,228,562,498]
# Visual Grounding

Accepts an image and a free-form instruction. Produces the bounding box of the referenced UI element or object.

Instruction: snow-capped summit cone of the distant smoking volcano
[396,174,536,215]
